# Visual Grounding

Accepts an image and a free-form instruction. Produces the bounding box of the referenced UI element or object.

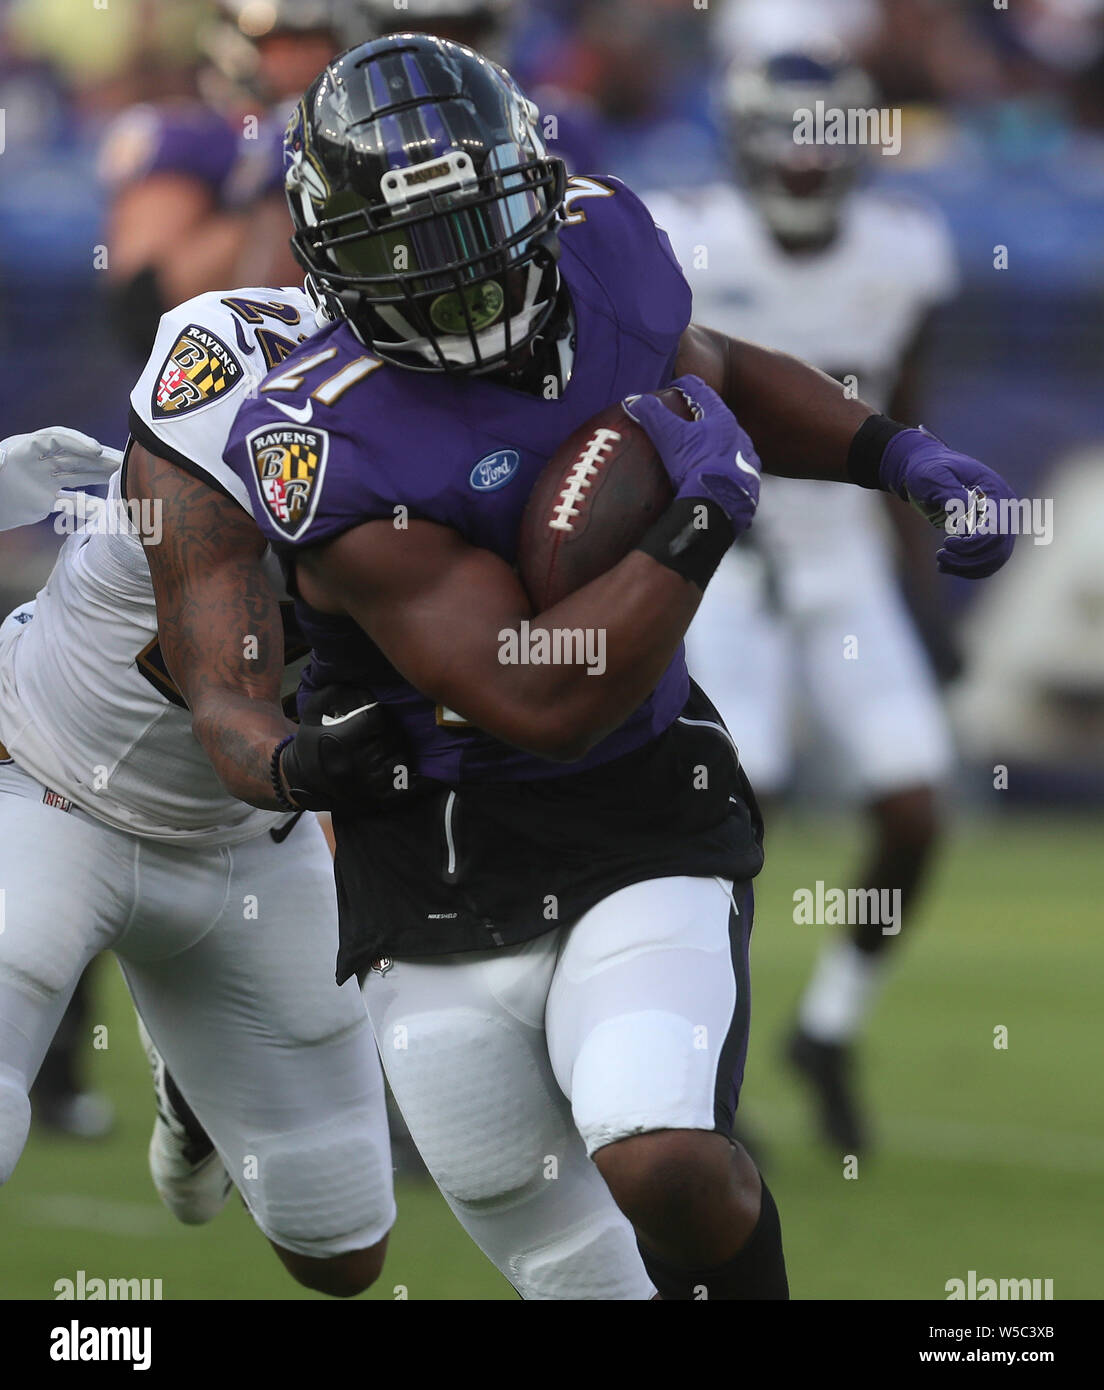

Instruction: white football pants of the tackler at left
[0,765,395,1259]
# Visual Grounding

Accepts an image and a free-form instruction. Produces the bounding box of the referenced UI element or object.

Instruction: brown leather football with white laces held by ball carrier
[517,386,691,613]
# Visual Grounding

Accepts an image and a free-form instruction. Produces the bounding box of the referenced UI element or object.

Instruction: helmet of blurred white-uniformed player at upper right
[723,47,875,245]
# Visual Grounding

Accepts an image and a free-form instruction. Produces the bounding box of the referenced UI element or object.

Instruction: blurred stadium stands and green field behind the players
[0,0,1104,1298]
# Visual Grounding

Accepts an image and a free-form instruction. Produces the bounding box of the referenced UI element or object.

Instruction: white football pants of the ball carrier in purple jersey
[364,878,752,1300]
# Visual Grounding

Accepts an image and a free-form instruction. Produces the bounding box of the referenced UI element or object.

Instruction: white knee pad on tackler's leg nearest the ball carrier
[239,1111,395,1259]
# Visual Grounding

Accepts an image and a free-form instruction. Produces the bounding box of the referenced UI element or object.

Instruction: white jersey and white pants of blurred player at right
[648,185,957,795]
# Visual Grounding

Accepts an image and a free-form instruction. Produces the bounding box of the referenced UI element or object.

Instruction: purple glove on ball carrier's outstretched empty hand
[879,430,1016,580]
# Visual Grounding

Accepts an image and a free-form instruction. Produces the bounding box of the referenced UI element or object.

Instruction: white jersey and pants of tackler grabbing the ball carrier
[0,289,395,1294]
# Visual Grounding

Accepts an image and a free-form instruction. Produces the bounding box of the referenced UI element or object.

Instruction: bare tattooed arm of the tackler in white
[127,445,295,809]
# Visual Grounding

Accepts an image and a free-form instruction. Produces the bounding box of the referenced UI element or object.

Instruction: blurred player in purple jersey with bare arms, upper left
[100,0,368,357]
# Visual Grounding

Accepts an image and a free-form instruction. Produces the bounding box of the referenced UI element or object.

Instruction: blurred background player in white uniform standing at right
[652,50,955,1152]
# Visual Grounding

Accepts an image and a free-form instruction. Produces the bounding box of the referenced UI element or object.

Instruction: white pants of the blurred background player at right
[687,555,952,801]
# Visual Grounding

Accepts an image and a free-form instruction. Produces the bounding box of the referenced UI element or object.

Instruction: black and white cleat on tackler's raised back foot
[138,1019,234,1226]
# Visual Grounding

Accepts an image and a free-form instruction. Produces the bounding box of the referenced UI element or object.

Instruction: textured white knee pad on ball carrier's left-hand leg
[380,1009,570,1208]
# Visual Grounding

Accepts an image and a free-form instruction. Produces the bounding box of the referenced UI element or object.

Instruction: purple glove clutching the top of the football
[623,377,761,535]
